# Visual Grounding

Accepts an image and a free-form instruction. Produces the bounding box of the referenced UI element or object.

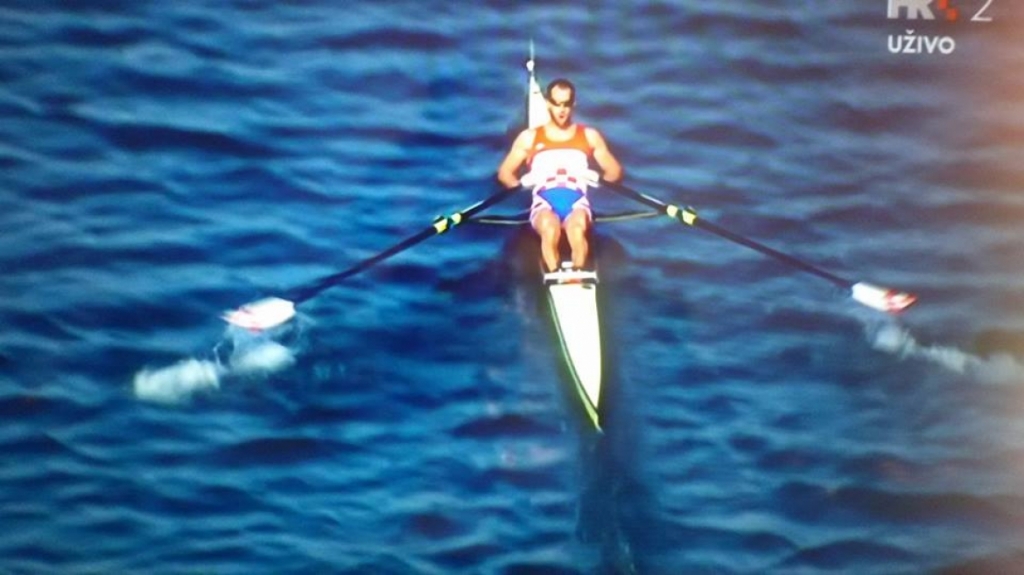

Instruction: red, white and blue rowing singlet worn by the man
[526,124,594,220]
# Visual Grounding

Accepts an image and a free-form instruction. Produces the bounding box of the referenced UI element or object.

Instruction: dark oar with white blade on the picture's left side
[221,188,516,330]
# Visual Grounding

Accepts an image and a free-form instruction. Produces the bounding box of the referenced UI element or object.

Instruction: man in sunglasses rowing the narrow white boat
[498,79,623,272]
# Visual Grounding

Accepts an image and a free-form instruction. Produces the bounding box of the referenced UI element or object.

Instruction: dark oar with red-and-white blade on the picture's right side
[601,180,918,313]
